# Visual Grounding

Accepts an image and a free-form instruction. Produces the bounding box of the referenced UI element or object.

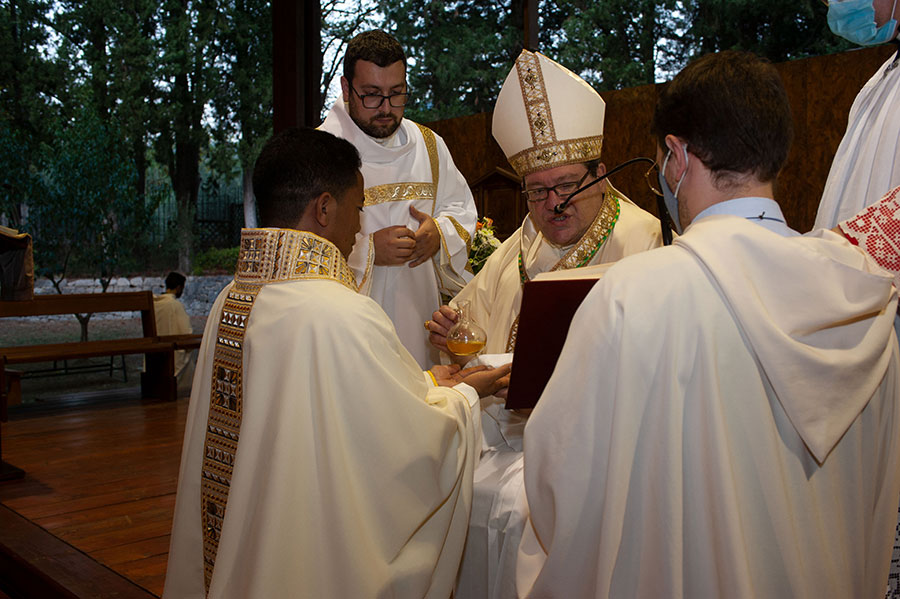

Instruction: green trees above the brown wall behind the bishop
[378,0,850,121]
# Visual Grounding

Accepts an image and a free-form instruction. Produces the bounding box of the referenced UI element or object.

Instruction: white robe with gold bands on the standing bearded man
[320,99,478,368]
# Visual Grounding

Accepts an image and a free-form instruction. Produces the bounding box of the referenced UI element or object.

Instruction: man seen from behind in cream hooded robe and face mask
[516,52,900,598]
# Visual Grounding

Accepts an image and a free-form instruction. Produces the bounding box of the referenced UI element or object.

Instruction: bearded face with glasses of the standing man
[341,60,406,138]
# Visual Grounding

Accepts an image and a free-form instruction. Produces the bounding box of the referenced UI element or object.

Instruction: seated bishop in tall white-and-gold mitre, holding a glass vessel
[426,50,662,599]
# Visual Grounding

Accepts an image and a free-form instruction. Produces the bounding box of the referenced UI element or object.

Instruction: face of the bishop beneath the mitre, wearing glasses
[524,164,606,247]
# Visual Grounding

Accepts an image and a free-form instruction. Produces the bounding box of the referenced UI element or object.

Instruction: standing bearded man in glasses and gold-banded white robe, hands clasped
[320,30,478,368]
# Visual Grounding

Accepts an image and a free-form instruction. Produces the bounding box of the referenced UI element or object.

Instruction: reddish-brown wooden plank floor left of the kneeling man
[0,394,188,596]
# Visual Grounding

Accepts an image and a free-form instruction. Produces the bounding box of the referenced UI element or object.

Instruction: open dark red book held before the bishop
[506,276,605,410]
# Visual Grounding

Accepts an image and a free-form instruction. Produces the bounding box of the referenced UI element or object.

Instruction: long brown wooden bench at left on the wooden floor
[0,291,202,480]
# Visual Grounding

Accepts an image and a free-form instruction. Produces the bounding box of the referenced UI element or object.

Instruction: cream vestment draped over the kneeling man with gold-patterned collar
[164,229,480,599]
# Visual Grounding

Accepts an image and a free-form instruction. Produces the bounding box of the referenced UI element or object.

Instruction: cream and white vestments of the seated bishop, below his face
[453,190,662,599]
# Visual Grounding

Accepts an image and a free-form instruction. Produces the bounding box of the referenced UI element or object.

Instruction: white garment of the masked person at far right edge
[814,47,900,229]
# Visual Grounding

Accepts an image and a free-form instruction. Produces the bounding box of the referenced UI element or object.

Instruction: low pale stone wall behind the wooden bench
[34,275,234,318]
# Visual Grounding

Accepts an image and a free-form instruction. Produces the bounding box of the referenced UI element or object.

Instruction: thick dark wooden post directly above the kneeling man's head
[272,0,322,133]
